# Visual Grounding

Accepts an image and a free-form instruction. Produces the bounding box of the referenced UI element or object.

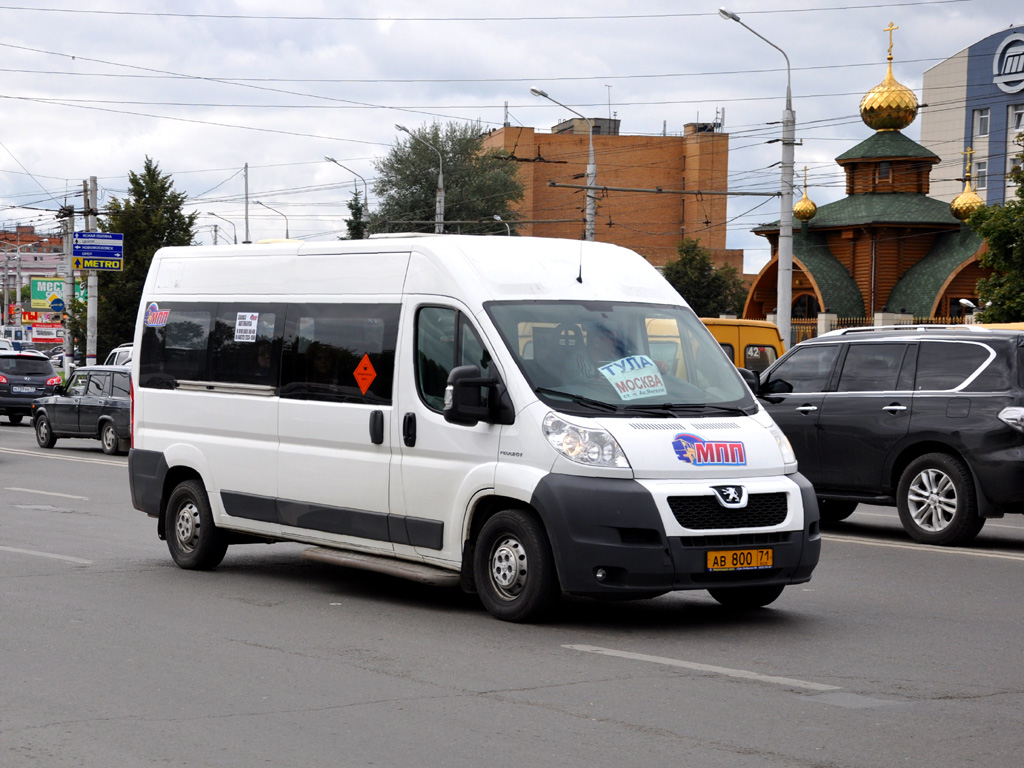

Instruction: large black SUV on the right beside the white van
[756,326,1024,545]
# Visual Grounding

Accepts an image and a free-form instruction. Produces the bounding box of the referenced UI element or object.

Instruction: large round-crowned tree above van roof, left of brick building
[372,122,522,233]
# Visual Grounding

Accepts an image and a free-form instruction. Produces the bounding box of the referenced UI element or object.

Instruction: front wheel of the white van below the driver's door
[473,509,561,622]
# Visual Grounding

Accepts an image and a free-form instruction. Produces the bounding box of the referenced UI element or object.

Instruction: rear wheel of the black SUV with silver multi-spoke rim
[896,454,985,547]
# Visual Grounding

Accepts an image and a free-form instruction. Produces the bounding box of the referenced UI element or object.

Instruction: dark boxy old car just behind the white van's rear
[32,366,131,455]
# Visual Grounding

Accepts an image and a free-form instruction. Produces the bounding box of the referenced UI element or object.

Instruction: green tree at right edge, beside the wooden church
[968,134,1024,323]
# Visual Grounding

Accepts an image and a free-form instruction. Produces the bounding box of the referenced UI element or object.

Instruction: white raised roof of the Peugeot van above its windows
[144,234,682,309]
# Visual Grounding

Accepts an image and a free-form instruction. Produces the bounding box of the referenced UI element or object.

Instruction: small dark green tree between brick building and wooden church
[664,238,746,317]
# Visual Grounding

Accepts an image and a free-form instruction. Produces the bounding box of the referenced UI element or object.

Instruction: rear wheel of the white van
[164,480,227,570]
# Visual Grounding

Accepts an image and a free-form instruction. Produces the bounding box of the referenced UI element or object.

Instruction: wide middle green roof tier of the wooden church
[754,193,959,232]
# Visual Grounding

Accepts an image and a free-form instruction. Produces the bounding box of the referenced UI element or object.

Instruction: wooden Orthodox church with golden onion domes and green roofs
[743,25,990,318]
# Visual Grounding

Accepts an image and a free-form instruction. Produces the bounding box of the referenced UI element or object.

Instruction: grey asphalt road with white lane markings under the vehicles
[0,419,1024,768]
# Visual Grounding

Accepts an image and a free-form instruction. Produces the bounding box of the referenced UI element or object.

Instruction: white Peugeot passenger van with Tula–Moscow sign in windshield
[129,236,820,622]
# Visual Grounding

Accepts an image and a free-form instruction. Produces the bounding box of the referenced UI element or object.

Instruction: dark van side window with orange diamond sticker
[281,304,400,404]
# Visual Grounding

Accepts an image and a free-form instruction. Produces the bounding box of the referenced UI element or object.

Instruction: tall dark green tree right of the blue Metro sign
[91,157,199,360]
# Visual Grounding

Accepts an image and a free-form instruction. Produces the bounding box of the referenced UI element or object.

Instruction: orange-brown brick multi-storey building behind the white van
[483,118,743,272]
